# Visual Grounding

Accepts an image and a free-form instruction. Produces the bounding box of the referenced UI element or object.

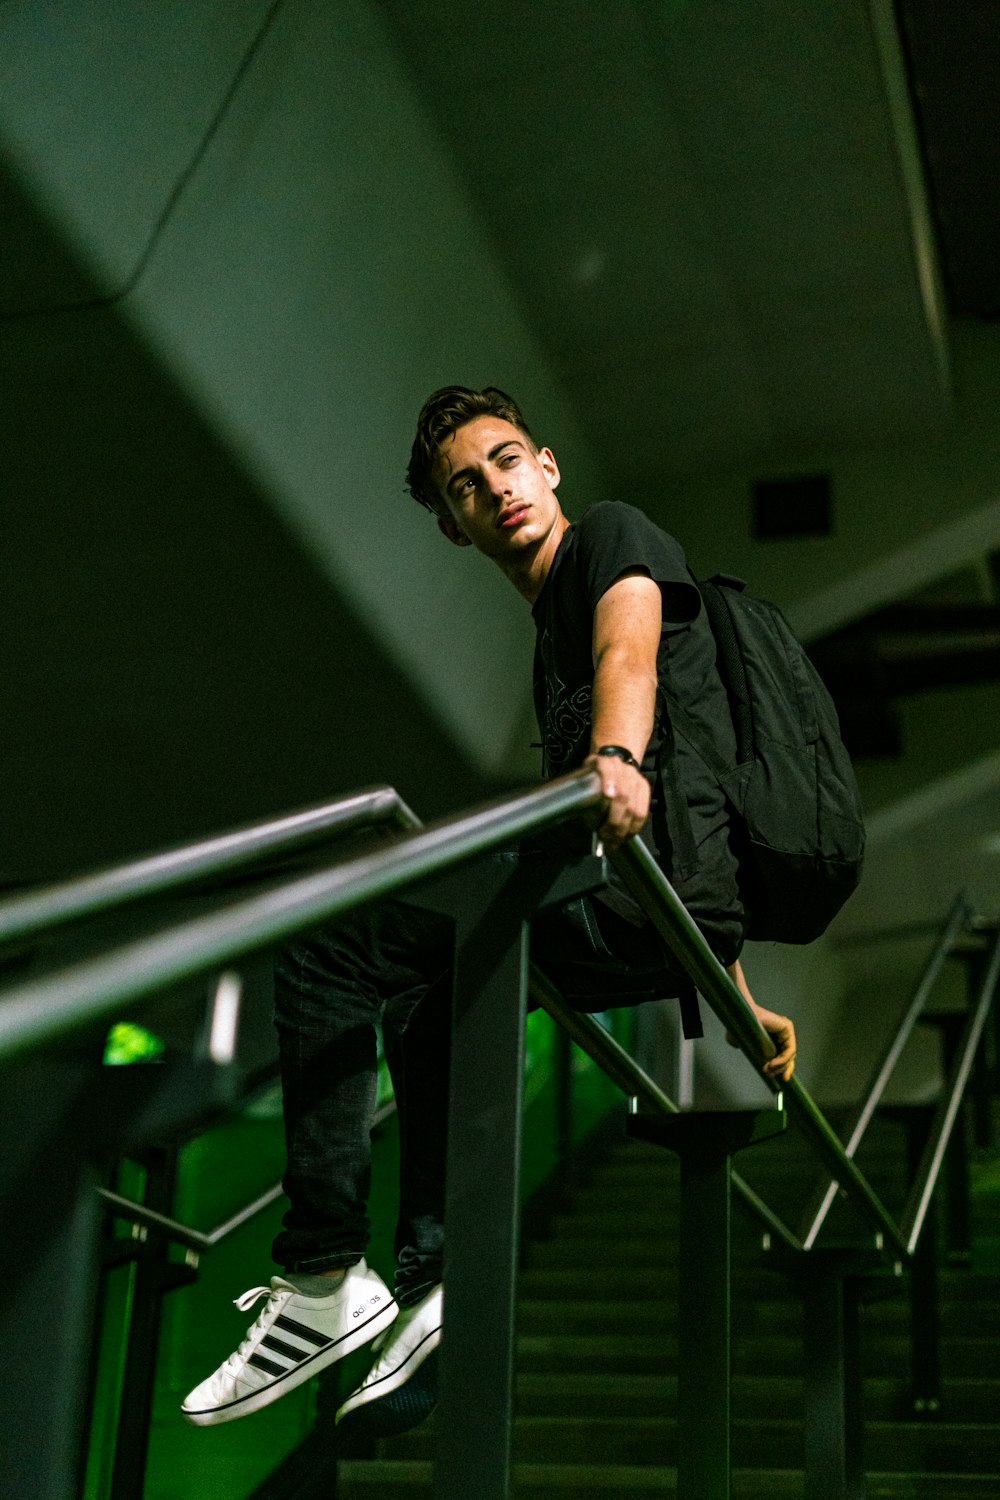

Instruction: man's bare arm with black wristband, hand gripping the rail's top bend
[585,573,661,849]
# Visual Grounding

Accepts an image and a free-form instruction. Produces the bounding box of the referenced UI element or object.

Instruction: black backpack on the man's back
[667,573,865,944]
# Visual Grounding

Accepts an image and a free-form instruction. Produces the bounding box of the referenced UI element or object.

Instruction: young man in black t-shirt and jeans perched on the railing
[183,387,795,1436]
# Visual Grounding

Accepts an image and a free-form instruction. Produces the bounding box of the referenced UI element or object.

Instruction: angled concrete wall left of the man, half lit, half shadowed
[0,0,598,879]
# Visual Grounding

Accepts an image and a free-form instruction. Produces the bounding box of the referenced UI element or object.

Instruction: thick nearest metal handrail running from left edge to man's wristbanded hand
[0,771,604,1061]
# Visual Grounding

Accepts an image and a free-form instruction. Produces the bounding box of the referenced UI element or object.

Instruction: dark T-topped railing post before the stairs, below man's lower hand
[628,1109,787,1500]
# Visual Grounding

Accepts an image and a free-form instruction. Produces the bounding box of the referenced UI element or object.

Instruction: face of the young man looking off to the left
[432,417,562,561]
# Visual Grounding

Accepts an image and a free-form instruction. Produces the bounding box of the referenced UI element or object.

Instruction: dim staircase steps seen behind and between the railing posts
[337,1128,1000,1500]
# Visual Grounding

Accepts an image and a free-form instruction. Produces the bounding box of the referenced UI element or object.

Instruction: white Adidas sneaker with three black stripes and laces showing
[181,1260,399,1427]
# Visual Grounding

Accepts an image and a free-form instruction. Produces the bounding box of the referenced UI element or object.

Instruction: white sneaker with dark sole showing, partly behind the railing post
[337,1286,444,1440]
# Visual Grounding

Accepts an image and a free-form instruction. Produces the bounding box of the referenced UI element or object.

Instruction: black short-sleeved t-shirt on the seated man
[532,501,736,926]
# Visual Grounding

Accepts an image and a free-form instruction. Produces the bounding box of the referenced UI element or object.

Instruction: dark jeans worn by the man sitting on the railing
[273,876,701,1304]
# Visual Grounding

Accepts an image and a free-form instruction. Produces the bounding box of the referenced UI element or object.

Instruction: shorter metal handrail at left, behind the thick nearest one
[0,786,420,942]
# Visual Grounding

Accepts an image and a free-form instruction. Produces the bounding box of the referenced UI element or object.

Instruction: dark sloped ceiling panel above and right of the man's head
[384,0,948,480]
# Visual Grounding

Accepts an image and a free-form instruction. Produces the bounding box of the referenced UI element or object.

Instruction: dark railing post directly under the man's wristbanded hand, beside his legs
[414,854,604,1500]
